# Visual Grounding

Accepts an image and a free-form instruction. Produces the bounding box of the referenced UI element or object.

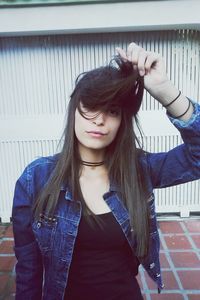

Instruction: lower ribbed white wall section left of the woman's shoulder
[0,139,59,222]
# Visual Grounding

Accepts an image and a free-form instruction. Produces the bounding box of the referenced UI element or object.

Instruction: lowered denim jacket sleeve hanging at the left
[12,168,43,300]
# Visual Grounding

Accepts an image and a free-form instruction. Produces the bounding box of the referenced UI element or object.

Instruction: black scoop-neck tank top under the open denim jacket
[65,212,143,300]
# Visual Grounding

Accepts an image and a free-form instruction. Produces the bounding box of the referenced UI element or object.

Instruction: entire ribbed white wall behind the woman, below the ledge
[0,30,200,221]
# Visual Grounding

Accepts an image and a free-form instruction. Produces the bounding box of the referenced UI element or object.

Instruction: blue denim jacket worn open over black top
[12,103,200,300]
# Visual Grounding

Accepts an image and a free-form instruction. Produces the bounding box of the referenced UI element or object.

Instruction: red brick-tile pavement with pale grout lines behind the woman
[0,218,200,300]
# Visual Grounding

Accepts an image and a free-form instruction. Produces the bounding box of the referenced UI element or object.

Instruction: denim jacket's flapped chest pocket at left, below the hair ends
[32,215,57,255]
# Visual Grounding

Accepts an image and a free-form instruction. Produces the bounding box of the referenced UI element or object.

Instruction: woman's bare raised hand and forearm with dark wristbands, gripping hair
[116,43,193,120]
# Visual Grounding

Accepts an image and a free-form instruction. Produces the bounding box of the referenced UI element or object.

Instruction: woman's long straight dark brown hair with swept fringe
[34,56,149,257]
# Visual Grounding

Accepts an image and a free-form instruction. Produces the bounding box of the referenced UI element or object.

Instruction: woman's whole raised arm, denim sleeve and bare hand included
[117,43,200,188]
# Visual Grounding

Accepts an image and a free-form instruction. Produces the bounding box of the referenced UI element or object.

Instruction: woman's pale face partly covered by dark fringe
[75,104,121,150]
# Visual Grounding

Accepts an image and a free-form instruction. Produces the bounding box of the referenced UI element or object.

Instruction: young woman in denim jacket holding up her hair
[12,43,200,300]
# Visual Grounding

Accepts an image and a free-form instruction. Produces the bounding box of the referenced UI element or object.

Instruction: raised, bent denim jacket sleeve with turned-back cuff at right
[147,101,200,188]
